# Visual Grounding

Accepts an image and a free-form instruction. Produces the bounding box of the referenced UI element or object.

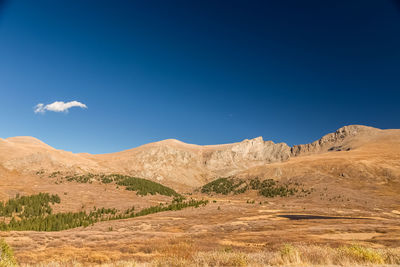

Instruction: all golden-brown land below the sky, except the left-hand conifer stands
[0,125,400,266]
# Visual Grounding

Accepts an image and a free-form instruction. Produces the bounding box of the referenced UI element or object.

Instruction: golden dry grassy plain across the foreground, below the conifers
[0,193,400,267]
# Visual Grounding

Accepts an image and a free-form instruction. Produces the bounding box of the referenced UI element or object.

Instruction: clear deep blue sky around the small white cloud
[0,0,400,153]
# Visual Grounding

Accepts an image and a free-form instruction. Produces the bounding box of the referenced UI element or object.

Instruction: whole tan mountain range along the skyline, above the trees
[0,125,400,190]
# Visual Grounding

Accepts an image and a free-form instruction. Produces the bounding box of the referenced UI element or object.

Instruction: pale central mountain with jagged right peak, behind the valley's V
[90,137,290,186]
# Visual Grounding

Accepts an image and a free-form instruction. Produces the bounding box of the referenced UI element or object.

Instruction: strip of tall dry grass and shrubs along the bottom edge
[22,244,400,267]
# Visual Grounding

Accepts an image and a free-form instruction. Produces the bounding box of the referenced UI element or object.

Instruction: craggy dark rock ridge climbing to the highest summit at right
[291,125,380,156]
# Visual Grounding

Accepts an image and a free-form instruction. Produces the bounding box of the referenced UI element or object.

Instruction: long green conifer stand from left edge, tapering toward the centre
[0,193,208,231]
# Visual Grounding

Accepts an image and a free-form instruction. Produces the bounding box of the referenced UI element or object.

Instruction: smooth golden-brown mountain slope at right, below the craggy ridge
[238,127,400,199]
